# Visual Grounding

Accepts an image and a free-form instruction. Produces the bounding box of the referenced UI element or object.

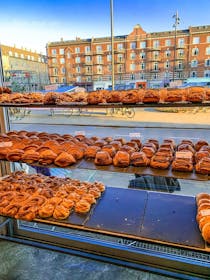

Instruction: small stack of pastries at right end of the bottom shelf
[196,193,210,243]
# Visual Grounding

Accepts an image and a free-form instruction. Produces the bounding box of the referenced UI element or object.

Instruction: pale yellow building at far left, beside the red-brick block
[0,45,49,91]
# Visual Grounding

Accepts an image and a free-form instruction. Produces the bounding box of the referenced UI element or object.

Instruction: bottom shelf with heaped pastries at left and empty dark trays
[0,171,210,252]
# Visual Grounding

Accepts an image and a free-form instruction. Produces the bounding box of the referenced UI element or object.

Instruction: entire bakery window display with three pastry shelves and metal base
[0,88,210,279]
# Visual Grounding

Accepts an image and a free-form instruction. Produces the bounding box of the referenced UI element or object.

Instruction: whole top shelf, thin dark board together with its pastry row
[0,87,210,108]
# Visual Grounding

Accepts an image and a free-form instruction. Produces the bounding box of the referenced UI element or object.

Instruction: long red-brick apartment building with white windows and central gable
[47,25,210,87]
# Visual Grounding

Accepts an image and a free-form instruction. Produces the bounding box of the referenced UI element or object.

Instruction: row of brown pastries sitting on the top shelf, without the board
[0,87,210,105]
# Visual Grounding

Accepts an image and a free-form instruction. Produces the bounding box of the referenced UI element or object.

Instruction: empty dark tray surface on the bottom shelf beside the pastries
[33,187,210,252]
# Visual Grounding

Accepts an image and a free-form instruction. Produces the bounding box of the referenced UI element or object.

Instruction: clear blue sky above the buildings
[0,0,210,54]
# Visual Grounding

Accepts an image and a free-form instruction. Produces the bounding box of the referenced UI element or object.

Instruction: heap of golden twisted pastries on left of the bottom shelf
[0,171,105,221]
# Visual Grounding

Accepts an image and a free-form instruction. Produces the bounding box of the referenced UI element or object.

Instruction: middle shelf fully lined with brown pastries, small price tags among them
[0,131,210,180]
